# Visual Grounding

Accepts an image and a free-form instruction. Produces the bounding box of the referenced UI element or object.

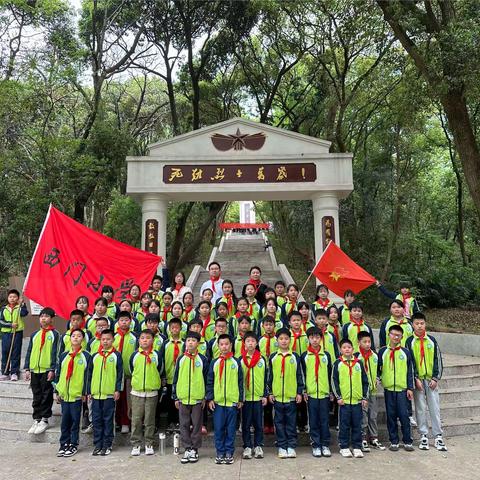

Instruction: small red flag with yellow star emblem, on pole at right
[312,242,375,297]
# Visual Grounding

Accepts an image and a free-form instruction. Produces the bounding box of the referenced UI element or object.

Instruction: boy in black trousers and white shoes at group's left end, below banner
[24,307,60,435]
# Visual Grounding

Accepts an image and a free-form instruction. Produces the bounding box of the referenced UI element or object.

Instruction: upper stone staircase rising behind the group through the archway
[190,233,287,297]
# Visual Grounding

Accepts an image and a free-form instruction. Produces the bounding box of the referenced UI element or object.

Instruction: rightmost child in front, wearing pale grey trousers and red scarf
[405,312,447,452]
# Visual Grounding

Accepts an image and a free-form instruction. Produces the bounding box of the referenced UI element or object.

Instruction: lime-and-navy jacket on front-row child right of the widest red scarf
[267,351,304,403]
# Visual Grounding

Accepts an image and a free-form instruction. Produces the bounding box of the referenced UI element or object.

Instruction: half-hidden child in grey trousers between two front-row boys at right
[355,332,385,452]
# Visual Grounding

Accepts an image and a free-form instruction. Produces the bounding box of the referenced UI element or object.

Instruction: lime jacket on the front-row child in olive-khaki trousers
[130,348,162,392]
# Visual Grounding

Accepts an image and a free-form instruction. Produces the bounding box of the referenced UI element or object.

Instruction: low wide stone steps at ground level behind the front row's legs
[0,354,480,447]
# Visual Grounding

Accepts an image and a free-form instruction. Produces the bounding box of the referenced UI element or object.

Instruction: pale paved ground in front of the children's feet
[0,435,480,480]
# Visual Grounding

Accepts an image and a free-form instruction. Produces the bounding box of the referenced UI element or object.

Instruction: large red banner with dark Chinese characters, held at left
[24,205,162,318]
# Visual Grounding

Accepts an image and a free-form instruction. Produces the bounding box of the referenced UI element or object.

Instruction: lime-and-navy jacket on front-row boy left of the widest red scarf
[207,357,244,407]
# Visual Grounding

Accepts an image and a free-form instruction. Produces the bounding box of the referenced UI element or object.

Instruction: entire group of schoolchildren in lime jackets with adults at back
[0,262,447,464]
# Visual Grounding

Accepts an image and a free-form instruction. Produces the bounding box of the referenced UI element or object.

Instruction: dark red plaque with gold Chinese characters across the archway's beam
[163,163,317,184]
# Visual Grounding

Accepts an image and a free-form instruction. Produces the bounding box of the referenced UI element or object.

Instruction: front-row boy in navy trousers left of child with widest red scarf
[206,334,244,465]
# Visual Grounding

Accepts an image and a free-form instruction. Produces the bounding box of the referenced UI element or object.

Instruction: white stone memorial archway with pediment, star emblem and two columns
[127,118,353,259]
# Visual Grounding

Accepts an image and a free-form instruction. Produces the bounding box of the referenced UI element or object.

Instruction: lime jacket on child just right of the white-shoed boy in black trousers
[54,350,91,402]
